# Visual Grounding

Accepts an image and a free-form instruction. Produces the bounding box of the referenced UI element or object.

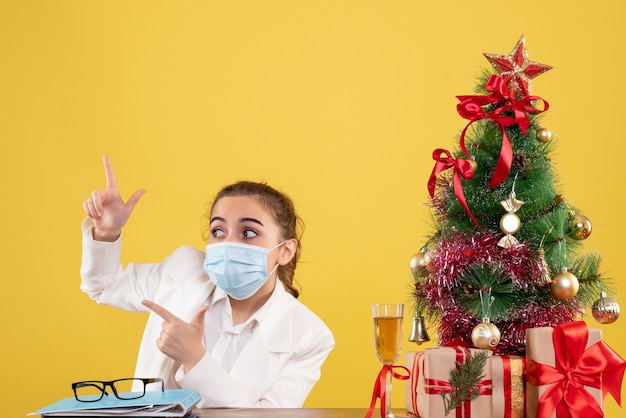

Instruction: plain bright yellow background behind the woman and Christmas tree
[0,0,626,417]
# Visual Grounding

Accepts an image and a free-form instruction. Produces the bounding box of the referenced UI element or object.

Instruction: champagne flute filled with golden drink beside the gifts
[372,303,404,418]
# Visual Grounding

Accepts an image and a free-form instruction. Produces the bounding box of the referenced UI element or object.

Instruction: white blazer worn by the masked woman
[80,218,335,408]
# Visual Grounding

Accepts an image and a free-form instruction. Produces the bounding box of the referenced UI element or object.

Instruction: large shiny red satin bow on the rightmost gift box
[526,321,626,418]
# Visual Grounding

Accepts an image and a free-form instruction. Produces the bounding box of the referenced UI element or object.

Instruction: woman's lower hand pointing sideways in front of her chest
[141,300,209,371]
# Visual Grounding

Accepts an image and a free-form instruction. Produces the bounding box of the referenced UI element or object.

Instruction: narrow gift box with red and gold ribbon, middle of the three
[489,356,526,418]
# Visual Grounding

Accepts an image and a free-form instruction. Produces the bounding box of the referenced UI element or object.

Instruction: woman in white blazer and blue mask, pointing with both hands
[81,157,334,408]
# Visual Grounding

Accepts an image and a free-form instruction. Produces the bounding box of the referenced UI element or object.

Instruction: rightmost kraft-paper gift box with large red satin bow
[526,321,626,418]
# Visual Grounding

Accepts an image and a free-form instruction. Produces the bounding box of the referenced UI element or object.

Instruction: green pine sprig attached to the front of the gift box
[441,351,487,416]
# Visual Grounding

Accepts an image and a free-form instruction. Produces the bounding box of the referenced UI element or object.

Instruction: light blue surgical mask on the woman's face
[203,241,286,300]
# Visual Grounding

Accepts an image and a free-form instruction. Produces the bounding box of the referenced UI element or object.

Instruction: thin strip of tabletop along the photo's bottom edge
[194,408,415,418]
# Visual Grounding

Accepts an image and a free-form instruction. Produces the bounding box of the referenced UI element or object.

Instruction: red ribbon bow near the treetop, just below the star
[457,75,550,188]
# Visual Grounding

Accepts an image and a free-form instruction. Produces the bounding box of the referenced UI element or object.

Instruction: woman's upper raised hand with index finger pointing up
[83,155,146,241]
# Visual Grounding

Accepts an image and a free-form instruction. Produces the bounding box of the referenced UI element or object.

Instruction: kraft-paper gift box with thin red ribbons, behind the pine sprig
[405,347,493,418]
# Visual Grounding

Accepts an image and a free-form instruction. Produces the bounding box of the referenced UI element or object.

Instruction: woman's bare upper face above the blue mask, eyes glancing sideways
[208,196,283,269]
